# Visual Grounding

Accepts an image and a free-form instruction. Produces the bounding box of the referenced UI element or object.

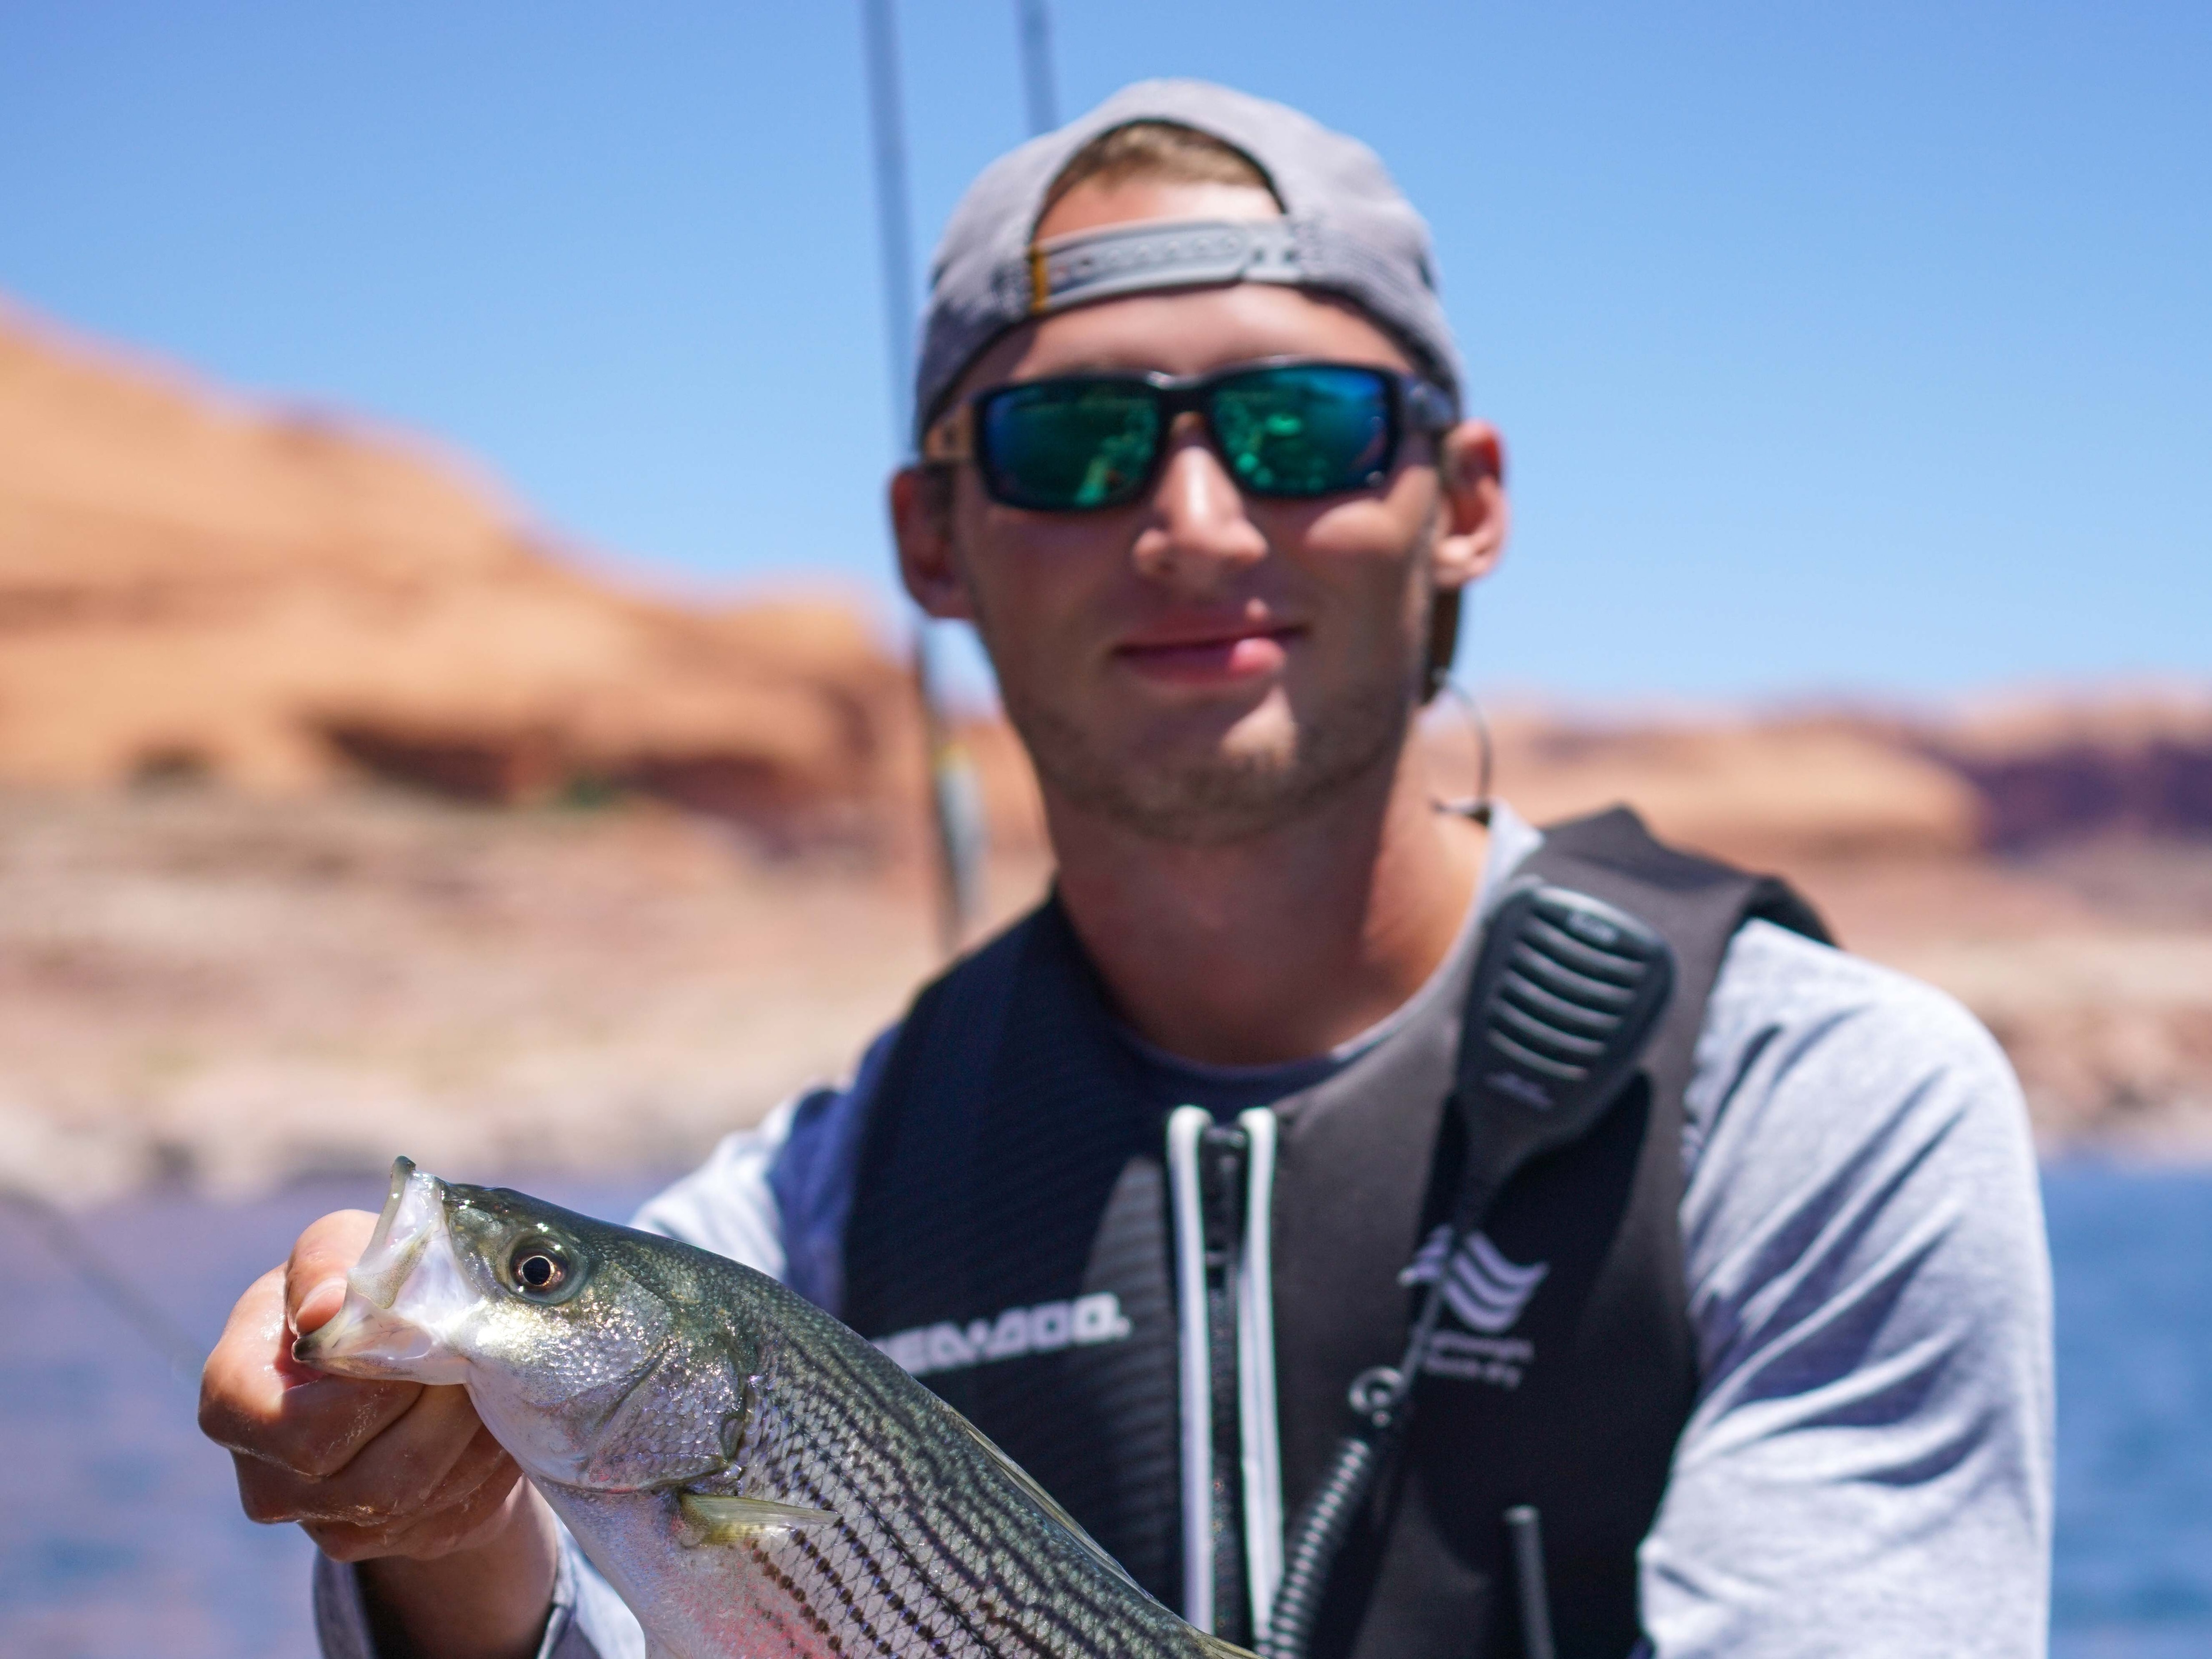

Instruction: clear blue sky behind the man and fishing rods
[0,0,2212,699]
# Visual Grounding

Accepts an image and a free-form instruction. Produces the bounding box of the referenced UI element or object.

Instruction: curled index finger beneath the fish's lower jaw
[199,1267,422,1475]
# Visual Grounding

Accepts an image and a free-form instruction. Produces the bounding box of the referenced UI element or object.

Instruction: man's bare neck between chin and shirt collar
[1046,743,1486,1066]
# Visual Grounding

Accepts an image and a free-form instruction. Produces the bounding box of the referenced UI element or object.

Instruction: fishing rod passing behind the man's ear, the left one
[860,0,989,956]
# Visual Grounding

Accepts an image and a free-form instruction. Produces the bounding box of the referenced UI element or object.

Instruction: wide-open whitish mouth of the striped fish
[292,1157,482,1382]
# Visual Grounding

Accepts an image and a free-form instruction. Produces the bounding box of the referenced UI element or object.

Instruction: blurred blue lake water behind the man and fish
[0,1166,2212,1659]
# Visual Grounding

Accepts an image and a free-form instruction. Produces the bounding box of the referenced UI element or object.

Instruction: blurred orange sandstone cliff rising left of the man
[0,296,911,834]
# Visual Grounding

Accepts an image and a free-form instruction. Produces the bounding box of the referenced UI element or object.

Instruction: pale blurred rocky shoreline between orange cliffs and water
[0,787,2212,1210]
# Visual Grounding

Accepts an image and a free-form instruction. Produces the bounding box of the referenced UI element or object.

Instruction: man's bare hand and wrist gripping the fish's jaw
[199,1210,555,1659]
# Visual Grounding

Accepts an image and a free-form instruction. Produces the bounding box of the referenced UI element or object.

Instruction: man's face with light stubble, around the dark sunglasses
[894,181,1502,843]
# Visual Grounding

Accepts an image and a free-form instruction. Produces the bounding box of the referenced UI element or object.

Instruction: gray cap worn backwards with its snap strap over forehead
[914,80,1460,438]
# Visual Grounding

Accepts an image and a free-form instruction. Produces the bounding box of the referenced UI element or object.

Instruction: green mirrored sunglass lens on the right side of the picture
[1212,365,1391,495]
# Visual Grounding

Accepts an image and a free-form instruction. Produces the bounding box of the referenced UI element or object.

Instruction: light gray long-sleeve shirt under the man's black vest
[316,812,2053,1659]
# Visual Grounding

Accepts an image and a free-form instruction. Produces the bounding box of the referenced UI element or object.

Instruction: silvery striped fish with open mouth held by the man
[294,1157,1250,1659]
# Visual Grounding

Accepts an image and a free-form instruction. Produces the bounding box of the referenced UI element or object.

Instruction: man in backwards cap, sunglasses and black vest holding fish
[201,82,2051,1659]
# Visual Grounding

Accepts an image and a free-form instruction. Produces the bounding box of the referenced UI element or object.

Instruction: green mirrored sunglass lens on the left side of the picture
[978,380,1159,513]
